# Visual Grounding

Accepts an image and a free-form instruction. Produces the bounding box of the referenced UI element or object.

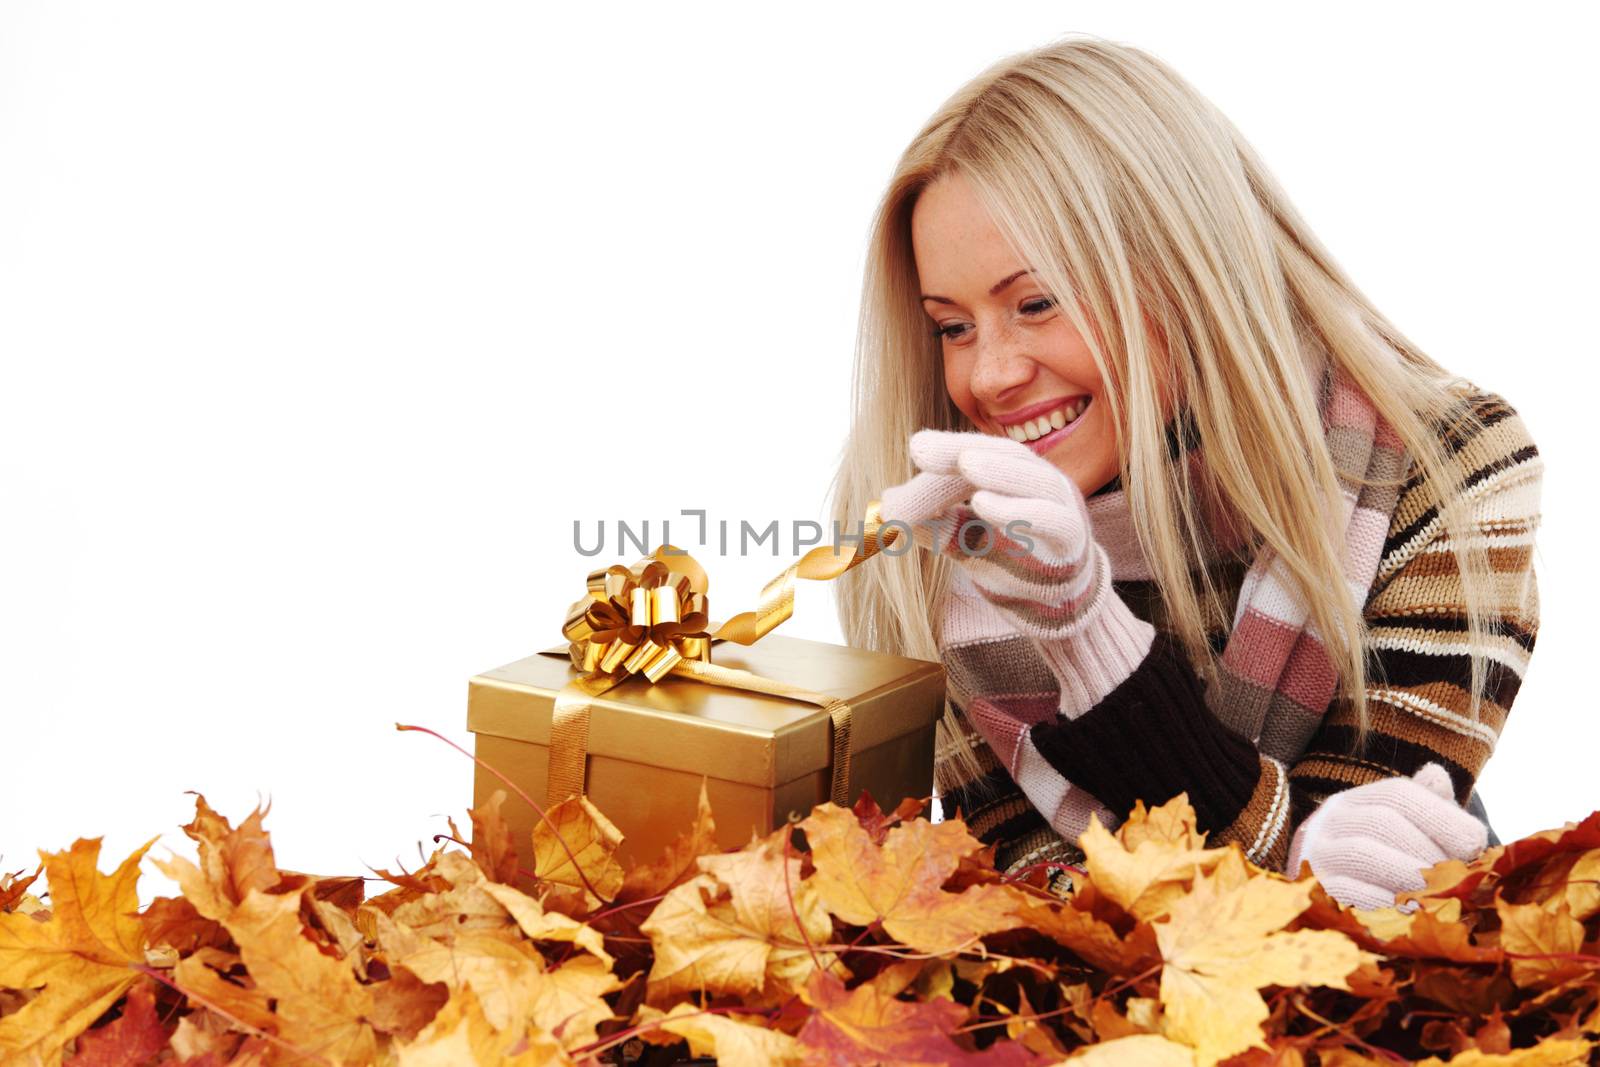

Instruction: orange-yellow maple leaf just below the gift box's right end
[800,803,1030,955]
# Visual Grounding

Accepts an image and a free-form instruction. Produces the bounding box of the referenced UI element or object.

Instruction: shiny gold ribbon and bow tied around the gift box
[546,501,899,806]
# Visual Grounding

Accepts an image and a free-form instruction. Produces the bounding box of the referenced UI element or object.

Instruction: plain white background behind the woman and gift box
[0,2,1600,901]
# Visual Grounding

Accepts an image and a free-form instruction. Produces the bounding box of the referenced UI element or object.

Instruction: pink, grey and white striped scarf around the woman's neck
[941,363,1408,840]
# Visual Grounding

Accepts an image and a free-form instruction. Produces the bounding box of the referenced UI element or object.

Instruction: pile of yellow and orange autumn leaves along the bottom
[0,780,1600,1067]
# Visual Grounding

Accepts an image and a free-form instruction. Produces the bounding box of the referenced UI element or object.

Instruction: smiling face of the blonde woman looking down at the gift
[910,173,1118,496]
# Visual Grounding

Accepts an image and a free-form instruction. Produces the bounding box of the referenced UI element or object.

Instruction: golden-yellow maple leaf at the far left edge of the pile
[0,837,158,1064]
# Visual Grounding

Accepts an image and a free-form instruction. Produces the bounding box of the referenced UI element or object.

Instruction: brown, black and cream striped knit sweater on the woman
[934,390,1542,891]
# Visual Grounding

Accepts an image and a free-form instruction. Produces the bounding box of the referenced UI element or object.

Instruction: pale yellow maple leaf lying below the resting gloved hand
[1155,872,1378,1067]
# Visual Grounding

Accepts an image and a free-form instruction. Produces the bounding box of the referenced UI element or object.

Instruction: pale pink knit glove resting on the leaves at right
[1288,763,1488,910]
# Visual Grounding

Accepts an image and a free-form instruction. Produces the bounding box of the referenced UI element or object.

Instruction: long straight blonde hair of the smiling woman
[832,35,1510,790]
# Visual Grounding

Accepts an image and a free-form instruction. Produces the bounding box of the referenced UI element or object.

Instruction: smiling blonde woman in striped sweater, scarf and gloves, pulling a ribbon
[835,38,1542,907]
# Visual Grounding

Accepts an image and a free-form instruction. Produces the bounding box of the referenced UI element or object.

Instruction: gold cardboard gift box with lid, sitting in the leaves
[467,633,944,869]
